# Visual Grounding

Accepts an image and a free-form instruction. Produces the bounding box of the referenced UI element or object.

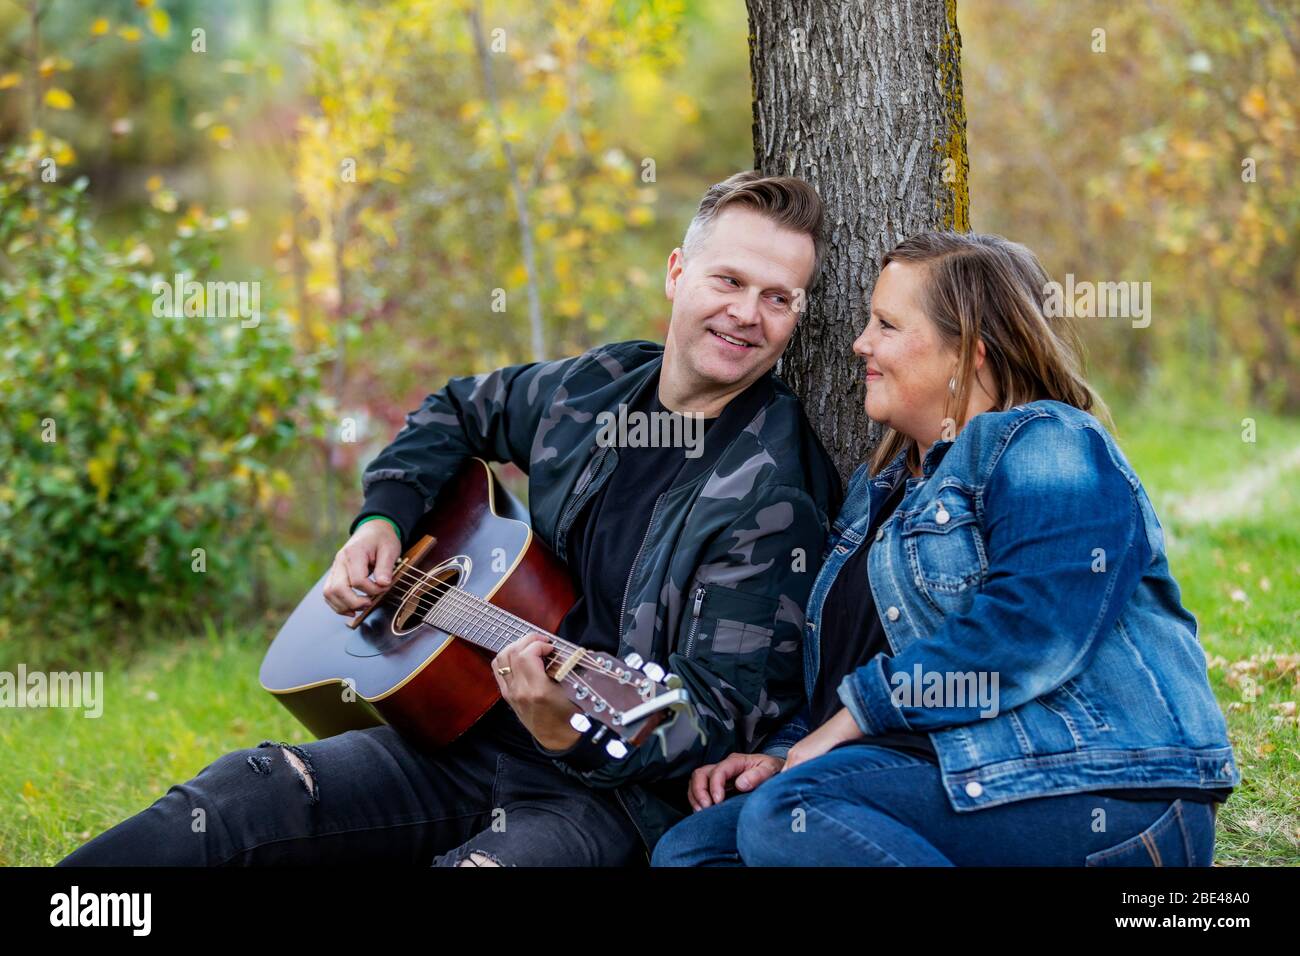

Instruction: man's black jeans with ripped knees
[59,702,646,866]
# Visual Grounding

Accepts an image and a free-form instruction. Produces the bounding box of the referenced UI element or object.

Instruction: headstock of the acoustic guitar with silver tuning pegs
[551,650,694,758]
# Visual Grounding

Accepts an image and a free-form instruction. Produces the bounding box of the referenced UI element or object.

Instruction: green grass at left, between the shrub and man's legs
[0,616,304,866]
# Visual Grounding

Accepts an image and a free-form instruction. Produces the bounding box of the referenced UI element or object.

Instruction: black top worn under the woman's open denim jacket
[811,476,1232,804]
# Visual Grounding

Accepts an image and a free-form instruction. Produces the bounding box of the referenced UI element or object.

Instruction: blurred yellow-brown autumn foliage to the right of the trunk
[959,0,1300,414]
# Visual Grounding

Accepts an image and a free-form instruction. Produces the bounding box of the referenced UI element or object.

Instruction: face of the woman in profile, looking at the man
[853,261,958,446]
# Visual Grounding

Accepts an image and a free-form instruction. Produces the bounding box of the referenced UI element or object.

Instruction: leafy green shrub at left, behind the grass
[0,135,320,662]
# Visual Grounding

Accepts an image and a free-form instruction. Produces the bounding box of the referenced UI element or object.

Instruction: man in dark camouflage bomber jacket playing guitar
[64,172,840,866]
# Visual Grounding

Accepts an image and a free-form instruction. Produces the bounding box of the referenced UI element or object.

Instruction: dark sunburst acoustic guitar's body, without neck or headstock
[259,458,576,750]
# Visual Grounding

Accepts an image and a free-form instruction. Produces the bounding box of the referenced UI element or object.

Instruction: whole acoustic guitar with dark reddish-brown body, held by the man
[260,458,696,758]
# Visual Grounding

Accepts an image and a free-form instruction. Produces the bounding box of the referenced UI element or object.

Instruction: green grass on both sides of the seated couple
[0,406,1300,865]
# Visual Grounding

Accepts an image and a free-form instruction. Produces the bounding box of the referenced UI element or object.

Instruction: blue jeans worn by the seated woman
[653,744,1216,866]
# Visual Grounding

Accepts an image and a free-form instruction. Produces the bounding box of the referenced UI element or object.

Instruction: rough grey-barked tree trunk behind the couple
[746,0,970,477]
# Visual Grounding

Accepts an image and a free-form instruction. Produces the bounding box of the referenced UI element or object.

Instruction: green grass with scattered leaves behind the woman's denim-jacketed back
[1115,408,1300,866]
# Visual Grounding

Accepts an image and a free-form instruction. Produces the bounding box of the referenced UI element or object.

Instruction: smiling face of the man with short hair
[664,207,815,392]
